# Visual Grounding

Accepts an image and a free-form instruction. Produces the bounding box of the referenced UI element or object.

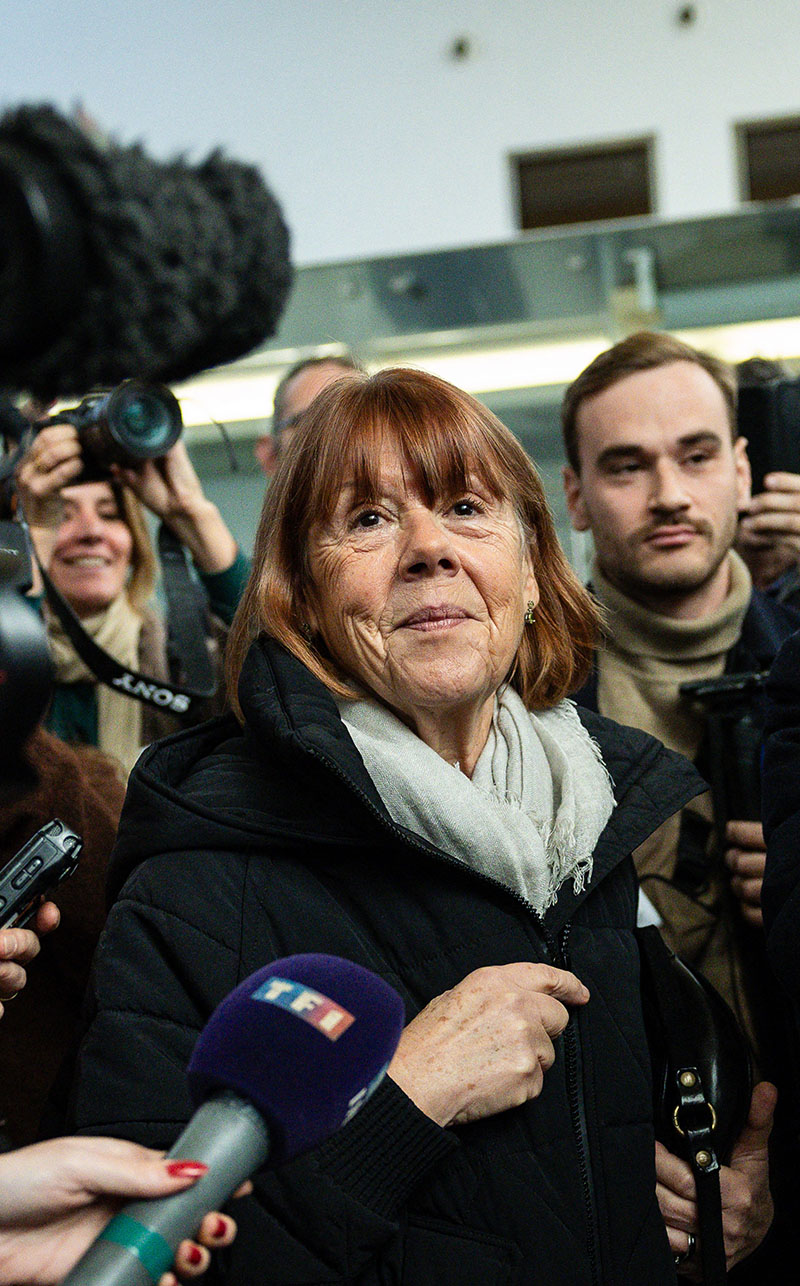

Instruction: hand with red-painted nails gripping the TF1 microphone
[0,1138,250,1286]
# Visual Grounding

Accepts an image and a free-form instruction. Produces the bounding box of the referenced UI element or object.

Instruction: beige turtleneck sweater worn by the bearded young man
[592,552,755,1051]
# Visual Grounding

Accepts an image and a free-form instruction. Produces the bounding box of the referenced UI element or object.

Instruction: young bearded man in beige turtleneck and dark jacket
[562,332,800,1281]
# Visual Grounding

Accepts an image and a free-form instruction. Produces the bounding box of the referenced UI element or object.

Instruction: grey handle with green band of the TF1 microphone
[62,1091,269,1286]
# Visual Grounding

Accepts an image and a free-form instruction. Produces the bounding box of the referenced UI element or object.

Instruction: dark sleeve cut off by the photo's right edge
[761,631,800,1001]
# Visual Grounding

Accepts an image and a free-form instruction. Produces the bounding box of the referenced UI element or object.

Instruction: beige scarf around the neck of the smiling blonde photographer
[45,594,141,778]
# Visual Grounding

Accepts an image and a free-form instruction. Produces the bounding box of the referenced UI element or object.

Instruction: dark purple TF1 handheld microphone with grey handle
[63,955,404,1286]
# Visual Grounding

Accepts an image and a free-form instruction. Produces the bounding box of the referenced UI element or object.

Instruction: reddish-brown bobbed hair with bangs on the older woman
[228,368,598,714]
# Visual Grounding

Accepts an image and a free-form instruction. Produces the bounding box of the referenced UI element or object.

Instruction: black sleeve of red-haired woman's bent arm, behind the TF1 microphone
[71,854,457,1286]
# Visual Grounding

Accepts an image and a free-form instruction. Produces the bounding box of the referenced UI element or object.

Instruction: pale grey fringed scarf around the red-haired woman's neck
[337,687,614,913]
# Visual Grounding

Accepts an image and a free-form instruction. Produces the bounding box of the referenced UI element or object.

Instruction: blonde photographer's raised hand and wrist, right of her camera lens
[114,440,237,574]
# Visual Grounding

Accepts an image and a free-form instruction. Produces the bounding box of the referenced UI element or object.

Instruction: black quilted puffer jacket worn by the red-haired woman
[72,643,702,1286]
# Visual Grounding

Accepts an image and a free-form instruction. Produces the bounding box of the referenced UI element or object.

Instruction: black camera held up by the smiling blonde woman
[46,379,183,472]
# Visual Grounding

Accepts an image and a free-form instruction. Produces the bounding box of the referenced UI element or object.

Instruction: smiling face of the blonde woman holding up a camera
[48,482,132,616]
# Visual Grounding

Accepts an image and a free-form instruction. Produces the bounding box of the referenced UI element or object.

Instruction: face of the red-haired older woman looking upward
[309,451,539,729]
